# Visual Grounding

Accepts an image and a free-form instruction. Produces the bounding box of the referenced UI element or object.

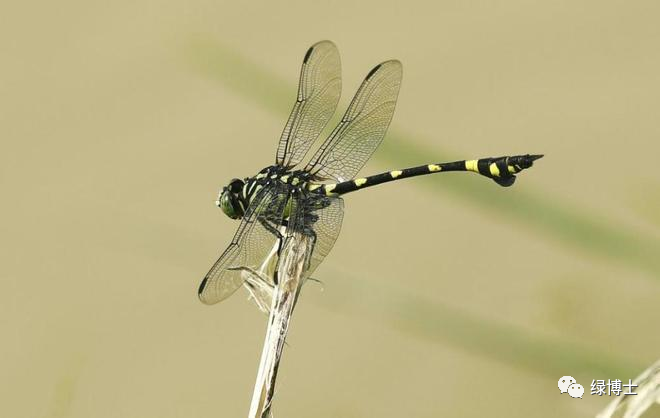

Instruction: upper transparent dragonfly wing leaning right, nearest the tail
[305,60,402,182]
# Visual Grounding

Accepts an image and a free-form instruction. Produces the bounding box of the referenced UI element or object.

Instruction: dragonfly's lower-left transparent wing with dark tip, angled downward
[198,182,289,305]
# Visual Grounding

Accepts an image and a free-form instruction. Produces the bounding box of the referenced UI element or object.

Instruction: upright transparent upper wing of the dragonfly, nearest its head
[275,41,341,168]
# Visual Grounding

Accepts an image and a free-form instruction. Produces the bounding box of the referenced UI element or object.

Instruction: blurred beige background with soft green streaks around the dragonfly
[0,0,660,418]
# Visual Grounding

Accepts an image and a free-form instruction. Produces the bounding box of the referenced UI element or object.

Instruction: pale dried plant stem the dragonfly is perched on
[248,234,311,418]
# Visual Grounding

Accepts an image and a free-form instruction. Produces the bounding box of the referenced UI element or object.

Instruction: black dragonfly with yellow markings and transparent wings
[198,41,543,311]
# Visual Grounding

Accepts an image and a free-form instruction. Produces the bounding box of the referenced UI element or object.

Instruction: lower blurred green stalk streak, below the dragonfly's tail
[320,271,643,380]
